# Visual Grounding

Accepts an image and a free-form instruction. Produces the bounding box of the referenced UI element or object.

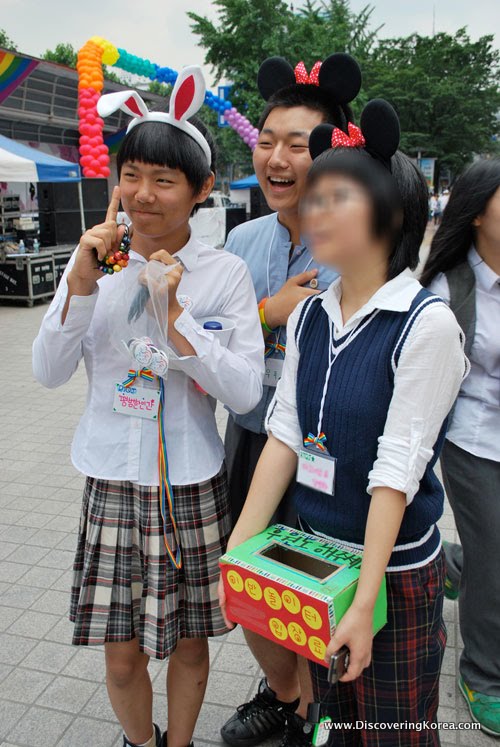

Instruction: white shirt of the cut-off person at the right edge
[430,247,500,462]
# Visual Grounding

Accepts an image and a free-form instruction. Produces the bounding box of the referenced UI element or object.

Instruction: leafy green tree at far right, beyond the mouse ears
[363,29,500,173]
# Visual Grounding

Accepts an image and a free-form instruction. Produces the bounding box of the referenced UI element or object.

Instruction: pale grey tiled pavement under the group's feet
[0,284,494,747]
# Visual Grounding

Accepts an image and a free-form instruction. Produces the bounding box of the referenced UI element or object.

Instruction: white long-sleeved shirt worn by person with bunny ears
[33,237,264,485]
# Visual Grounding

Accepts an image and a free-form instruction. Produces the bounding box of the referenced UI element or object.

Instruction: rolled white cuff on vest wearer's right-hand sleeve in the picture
[368,418,434,506]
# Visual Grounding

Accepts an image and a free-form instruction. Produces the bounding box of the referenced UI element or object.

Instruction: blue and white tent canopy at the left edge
[0,135,81,182]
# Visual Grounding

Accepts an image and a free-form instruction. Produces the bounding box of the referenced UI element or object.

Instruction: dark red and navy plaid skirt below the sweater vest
[309,553,446,747]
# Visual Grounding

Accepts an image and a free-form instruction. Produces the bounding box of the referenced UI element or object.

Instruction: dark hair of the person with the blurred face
[308,148,428,280]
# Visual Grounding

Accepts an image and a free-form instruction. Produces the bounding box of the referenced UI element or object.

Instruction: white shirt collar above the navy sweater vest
[322,269,422,329]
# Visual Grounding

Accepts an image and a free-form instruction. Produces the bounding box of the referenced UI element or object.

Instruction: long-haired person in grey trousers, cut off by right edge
[421,159,500,736]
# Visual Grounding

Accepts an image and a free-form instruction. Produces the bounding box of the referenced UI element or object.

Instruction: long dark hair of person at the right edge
[421,158,500,285]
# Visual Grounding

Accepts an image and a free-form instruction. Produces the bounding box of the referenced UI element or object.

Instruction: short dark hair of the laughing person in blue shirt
[257,85,353,132]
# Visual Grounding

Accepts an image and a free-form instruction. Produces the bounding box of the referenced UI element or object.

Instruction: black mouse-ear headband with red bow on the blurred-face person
[309,99,401,171]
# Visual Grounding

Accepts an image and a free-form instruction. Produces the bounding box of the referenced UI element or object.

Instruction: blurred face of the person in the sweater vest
[301,174,376,272]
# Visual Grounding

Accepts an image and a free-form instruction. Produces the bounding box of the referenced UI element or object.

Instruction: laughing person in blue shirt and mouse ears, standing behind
[221,54,361,747]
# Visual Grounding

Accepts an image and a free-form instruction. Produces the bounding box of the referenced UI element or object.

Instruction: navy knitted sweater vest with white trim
[295,289,446,564]
